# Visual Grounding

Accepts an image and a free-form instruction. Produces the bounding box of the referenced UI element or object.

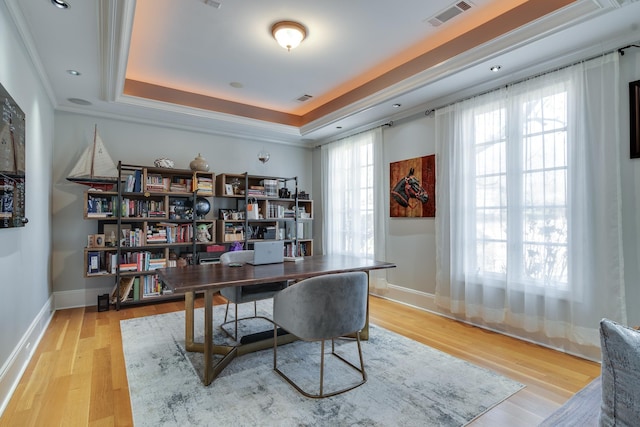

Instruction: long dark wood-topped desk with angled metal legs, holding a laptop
[157,255,395,385]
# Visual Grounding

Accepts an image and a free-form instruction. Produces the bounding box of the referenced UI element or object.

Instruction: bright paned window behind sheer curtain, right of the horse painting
[470,90,568,288]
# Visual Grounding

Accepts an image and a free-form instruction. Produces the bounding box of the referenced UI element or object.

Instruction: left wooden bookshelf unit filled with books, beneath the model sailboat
[83,162,216,308]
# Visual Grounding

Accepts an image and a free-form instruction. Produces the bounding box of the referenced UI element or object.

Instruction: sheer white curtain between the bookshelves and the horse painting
[322,127,387,287]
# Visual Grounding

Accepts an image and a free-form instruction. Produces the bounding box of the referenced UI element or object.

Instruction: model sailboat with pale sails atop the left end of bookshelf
[67,126,118,191]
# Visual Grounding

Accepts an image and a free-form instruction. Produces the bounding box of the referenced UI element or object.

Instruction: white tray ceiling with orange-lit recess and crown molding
[3,0,640,146]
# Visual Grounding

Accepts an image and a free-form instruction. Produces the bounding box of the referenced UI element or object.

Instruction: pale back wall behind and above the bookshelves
[52,112,314,308]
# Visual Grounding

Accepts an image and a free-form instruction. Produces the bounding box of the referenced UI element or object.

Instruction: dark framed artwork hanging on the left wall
[0,85,28,228]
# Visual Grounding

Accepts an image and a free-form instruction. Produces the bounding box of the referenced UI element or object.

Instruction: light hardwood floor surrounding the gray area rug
[0,297,600,427]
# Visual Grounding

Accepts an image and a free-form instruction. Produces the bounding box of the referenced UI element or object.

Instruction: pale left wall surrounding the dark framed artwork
[0,2,54,413]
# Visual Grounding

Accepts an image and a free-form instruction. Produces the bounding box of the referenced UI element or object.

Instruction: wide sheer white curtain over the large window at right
[436,53,626,359]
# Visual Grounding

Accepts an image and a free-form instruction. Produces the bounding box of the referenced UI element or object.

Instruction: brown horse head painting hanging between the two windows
[389,154,436,218]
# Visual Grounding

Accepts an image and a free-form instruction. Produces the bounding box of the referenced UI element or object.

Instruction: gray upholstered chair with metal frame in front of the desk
[273,272,368,398]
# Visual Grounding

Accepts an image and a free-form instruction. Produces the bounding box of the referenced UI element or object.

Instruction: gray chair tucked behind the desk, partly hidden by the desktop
[220,250,287,341]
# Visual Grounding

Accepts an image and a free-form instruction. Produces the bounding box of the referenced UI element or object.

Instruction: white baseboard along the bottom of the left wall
[0,296,55,416]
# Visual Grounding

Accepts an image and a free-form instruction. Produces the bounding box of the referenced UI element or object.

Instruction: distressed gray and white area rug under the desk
[120,301,523,427]
